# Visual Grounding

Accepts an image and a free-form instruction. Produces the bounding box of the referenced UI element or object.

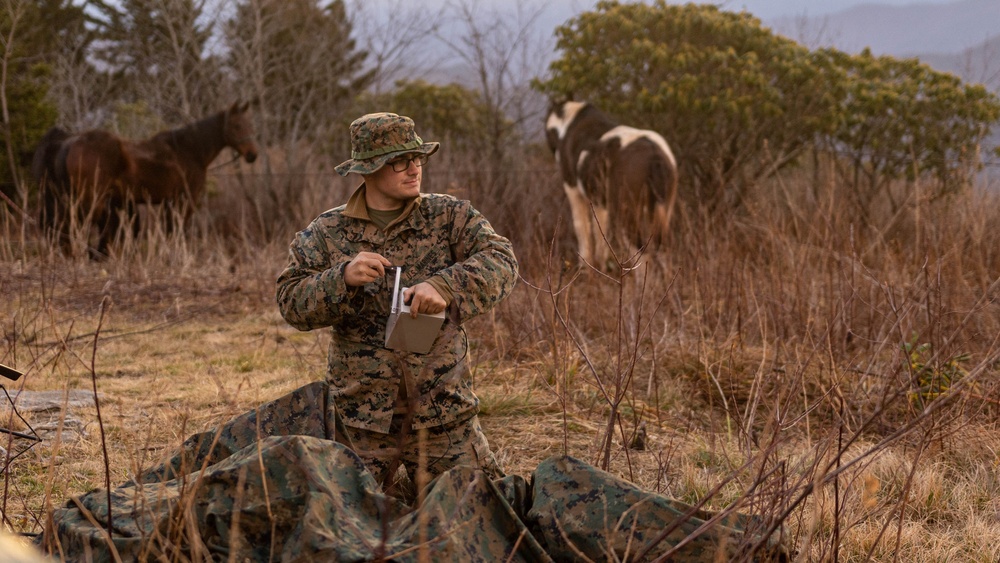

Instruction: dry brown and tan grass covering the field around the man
[0,161,1000,562]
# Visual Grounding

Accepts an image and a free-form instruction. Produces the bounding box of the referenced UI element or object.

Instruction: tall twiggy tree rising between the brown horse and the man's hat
[225,0,372,235]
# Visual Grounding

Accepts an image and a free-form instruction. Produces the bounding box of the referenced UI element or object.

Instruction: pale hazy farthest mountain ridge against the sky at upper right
[765,0,1000,56]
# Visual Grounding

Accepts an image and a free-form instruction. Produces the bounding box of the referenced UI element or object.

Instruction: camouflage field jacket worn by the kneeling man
[277,185,517,432]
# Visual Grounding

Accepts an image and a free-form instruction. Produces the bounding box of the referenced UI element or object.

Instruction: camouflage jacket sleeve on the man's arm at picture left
[276,222,365,330]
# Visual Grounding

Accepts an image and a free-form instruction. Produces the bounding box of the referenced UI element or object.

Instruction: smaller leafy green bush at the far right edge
[817,49,1000,217]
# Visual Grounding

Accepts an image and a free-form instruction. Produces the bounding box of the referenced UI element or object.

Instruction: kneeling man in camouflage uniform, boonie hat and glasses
[277,113,517,494]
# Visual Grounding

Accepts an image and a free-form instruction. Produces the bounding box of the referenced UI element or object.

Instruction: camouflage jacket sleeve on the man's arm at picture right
[439,202,518,323]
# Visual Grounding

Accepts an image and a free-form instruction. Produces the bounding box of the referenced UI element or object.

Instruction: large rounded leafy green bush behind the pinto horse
[535,0,835,214]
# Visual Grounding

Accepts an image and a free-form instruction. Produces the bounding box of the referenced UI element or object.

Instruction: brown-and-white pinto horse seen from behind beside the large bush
[545,101,677,270]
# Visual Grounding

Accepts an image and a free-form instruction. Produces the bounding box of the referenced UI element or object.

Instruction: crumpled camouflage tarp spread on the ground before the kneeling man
[40,382,788,562]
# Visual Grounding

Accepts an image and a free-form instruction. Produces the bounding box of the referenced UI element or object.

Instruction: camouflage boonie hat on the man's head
[336,112,439,176]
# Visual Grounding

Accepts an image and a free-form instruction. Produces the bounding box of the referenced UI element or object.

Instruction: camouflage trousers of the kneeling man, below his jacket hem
[342,414,505,494]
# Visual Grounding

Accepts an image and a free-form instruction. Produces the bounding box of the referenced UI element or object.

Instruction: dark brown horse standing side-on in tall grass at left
[31,103,257,257]
